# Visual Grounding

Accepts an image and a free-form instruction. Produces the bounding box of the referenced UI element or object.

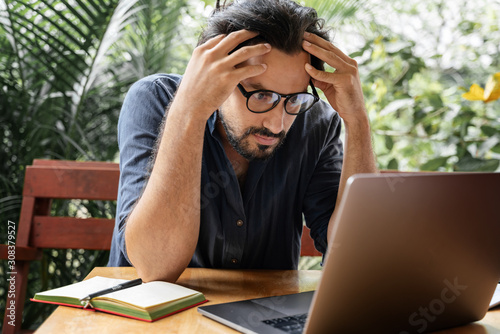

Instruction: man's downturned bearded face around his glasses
[218,49,310,160]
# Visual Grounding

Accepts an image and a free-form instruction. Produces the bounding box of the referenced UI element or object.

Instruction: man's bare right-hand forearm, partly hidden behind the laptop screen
[328,116,377,238]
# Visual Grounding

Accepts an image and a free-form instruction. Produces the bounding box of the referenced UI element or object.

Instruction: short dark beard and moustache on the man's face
[217,110,286,161]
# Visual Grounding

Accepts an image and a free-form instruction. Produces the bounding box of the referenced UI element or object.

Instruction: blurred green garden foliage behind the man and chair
[0,0,500,328]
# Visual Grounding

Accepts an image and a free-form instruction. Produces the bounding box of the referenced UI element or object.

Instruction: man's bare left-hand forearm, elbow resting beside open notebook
[125,100,206,281]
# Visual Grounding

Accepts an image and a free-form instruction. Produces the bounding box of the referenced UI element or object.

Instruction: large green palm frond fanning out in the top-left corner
[2,0,141,143]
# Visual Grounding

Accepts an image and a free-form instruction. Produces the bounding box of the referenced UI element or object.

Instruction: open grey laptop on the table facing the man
[198,173,500,334]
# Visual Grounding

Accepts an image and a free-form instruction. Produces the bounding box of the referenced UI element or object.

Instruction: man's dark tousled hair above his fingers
[198,0,329,70]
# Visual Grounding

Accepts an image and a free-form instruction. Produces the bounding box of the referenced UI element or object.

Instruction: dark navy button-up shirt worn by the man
[108,74,343,269]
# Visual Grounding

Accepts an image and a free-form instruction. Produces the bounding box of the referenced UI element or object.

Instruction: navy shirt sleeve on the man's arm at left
[108,75,180,266]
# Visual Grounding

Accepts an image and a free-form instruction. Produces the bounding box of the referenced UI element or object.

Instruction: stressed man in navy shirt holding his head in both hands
[109,0,376,281]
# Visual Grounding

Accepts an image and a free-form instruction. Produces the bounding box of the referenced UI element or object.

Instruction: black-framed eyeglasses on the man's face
[238,80,319,115]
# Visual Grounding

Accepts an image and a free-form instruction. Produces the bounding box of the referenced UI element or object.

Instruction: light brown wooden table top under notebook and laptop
[36,267,500,334]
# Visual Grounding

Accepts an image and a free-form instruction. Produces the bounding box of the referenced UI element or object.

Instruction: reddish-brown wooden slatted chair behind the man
[0,160,321,333]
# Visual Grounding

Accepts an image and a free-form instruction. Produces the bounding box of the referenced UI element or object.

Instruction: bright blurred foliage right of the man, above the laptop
[314,0,500,171]
